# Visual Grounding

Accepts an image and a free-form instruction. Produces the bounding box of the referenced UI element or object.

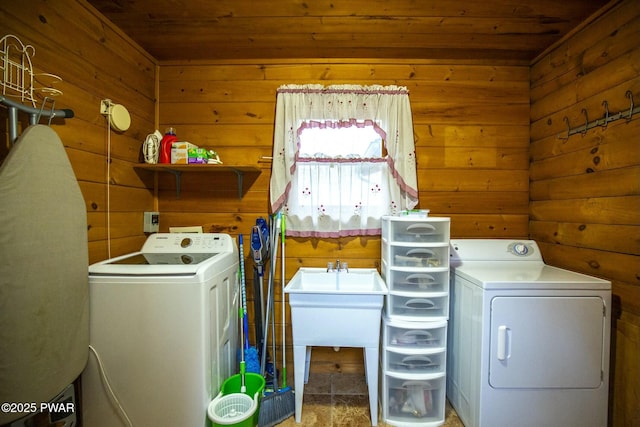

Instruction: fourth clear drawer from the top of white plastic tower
[386,292,449,321]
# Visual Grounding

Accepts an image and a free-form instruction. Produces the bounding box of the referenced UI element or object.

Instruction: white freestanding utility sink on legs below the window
[284,268,388,426]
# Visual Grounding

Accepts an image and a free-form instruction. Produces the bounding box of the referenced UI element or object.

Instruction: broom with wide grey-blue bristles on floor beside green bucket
[258,212,296,427]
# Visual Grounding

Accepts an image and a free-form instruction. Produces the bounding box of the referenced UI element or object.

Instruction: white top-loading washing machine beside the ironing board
[82,233,239,427]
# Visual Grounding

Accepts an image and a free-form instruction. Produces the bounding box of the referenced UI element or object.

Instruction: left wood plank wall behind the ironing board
[0,0,156,262]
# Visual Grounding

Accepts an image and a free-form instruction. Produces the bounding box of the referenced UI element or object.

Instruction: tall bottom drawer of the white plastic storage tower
[382,373,446,426]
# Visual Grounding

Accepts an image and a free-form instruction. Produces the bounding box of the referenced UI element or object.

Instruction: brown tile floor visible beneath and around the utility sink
[278,374,464,427]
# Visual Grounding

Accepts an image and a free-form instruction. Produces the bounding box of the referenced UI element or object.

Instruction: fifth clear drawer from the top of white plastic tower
[383,318,447,352]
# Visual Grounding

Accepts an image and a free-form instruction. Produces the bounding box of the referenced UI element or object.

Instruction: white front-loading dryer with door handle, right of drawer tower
[447,239,611,427]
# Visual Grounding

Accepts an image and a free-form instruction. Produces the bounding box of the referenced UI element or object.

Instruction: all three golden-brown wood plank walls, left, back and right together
[0,0,640,426]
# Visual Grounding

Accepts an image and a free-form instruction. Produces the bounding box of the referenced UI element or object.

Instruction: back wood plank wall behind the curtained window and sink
[158,60,529,372]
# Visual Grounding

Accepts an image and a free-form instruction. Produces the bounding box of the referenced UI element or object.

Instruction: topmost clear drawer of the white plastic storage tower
[382,217,449,243]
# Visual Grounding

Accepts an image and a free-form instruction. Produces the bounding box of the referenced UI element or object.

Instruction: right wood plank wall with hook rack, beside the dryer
[529,0,640,426]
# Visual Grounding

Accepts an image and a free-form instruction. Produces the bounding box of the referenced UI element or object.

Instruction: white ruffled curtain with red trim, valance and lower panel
[270,85,418,237]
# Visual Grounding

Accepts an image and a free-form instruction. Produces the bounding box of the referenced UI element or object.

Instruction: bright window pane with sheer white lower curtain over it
[287,122,389,237]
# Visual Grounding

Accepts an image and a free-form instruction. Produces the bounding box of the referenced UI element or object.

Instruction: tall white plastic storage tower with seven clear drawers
[379,215,450,427]
